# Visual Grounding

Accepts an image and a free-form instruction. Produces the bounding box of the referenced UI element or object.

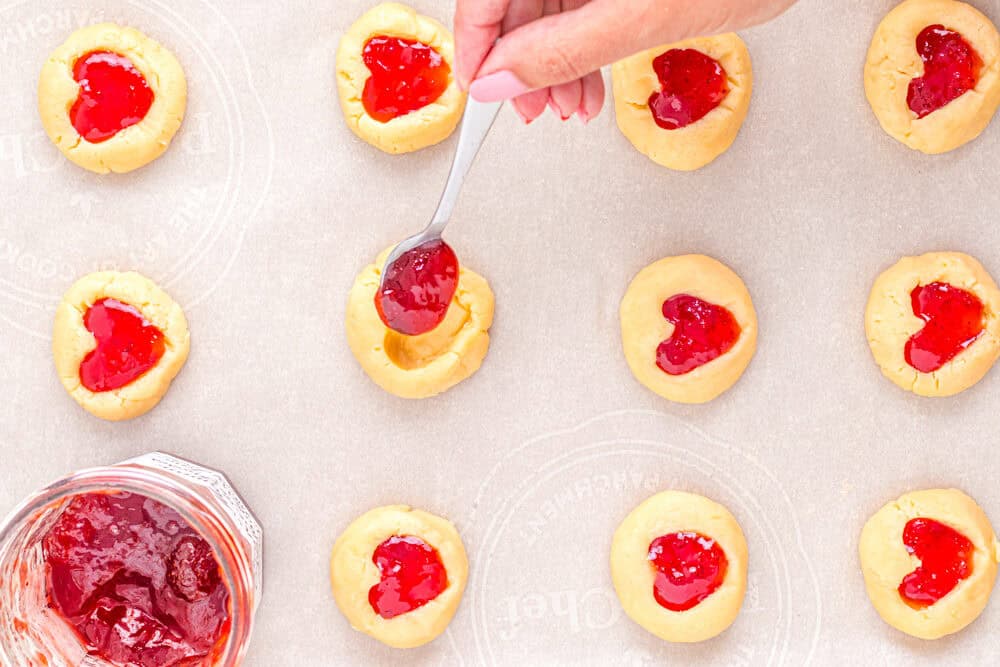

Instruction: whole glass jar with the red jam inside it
[0,453,262,667]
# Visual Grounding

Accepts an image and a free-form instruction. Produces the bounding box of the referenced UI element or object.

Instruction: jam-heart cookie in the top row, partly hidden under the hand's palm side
[611,33,753,171]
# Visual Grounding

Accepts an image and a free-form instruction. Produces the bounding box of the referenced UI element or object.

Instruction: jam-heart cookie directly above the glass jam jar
[52,271,191,421]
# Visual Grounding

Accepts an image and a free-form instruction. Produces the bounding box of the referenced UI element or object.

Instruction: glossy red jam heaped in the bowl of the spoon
[375,239,458,336]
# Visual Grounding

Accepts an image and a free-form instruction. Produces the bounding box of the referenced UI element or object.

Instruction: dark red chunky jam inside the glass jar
[42,493,230,667]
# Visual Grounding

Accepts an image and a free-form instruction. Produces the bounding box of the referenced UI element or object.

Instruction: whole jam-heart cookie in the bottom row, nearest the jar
[330,505,469,648]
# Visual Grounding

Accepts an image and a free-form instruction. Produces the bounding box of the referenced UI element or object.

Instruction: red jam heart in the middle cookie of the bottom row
[648,532,729,611]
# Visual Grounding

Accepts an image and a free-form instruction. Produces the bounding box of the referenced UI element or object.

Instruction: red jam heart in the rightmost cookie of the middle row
[903,283,983,373]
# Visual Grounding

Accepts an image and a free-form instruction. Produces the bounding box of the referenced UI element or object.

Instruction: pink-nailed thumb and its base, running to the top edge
[470,0,794,102]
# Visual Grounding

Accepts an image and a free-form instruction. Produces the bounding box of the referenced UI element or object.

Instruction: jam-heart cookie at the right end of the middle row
[865,252,1000,396]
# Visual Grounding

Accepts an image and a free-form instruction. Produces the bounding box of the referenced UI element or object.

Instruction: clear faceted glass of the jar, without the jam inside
[0,452,263,667]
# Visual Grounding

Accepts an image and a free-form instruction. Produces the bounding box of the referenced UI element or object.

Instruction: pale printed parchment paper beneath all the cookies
[0,0,1000,667]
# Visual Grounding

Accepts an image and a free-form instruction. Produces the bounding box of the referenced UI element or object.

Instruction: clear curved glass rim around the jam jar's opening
[0,461,259,667]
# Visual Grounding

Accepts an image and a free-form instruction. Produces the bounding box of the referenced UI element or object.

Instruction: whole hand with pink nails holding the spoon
[455,0,795,123]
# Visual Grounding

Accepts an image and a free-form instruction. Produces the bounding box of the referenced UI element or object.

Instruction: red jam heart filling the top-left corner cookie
[69,51,154,144]
